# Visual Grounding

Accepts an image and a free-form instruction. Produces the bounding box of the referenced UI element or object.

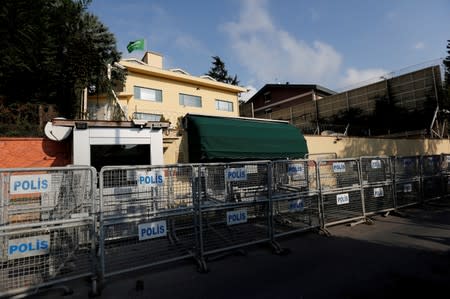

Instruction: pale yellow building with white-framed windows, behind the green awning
[84,52,247,164]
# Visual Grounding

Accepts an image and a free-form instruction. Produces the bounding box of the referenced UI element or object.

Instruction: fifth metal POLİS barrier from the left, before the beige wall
[319,159,365,227]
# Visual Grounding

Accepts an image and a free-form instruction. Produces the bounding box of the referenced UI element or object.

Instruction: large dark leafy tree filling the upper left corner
[0,0,125,118]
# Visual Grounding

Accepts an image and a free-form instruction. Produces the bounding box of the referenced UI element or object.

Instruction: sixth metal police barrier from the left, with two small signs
[360,156,395,215]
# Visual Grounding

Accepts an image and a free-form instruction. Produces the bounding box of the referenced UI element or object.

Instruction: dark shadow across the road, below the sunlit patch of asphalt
[36,224,450,299]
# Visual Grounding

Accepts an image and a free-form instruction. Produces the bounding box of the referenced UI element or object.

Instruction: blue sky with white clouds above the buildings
[89,0,450,101]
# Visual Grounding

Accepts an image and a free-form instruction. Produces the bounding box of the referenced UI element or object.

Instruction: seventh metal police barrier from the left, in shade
[393,156,421,208]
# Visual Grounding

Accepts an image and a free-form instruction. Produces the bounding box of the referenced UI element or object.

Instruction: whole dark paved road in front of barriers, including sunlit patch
[30,202,450,299]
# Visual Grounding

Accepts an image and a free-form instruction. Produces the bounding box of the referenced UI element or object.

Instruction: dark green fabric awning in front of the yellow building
[185,114,308,163]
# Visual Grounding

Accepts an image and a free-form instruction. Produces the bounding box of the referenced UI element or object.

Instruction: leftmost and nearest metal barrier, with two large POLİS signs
[0,167,96,297]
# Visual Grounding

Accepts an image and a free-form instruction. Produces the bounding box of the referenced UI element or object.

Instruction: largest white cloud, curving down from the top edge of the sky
[224,0,342,83]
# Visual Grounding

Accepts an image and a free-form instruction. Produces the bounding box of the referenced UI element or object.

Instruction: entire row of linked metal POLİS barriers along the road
[0,154,450,297]
